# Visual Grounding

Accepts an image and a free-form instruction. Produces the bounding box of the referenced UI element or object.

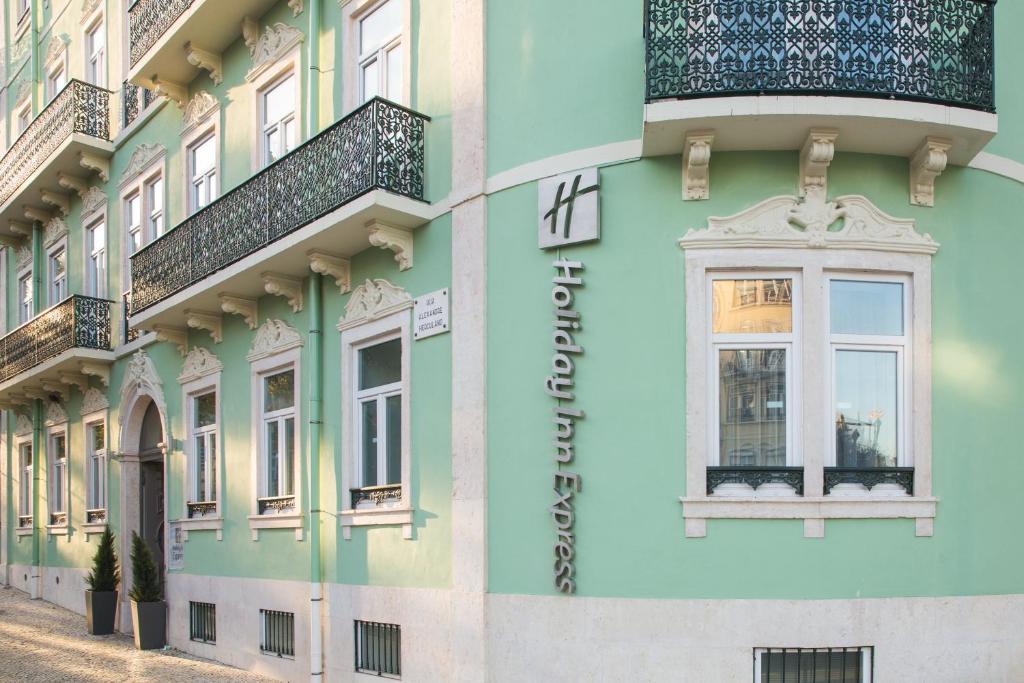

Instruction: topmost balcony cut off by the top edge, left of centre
[128,0,288,88]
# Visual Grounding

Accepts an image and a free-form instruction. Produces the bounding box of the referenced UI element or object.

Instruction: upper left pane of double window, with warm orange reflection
[712,280,793,334]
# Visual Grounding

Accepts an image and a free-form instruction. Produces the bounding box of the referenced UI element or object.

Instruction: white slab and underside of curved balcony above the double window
[643,95,998,166]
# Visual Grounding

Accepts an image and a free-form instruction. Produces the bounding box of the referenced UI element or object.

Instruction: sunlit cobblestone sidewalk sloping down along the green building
[0,588,272,683]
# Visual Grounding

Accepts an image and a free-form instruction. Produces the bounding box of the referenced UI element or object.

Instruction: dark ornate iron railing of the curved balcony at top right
[644,0,995,112]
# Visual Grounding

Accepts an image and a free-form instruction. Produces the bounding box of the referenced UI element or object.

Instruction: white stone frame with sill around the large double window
[681,245,936,538]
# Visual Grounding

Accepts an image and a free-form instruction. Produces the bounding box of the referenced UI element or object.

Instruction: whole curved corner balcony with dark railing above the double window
[643,0,997,165]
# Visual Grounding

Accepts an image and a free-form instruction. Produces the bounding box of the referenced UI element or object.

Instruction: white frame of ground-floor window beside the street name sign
[339,309,413,540]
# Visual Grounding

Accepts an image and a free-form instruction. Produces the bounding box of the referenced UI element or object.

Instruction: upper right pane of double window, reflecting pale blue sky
[828,280,903,337]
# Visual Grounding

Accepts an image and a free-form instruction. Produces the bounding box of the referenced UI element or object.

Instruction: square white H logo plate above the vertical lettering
[537,168,601,249]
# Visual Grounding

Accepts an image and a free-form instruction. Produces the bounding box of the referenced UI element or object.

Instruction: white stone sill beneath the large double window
[679,493,938,539]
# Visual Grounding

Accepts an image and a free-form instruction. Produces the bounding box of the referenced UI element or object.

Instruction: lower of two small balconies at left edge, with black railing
[0,294,114,409]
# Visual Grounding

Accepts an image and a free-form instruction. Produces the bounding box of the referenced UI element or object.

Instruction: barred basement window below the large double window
[754,647,873,683]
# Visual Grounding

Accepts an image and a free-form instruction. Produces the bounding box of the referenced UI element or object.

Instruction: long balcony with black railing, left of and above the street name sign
[129,98,432,333]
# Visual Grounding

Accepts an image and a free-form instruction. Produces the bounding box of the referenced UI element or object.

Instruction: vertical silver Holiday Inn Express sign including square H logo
[538,168,601,594]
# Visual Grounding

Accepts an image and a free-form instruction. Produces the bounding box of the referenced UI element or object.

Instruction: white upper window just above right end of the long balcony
[358,0,404,103]
